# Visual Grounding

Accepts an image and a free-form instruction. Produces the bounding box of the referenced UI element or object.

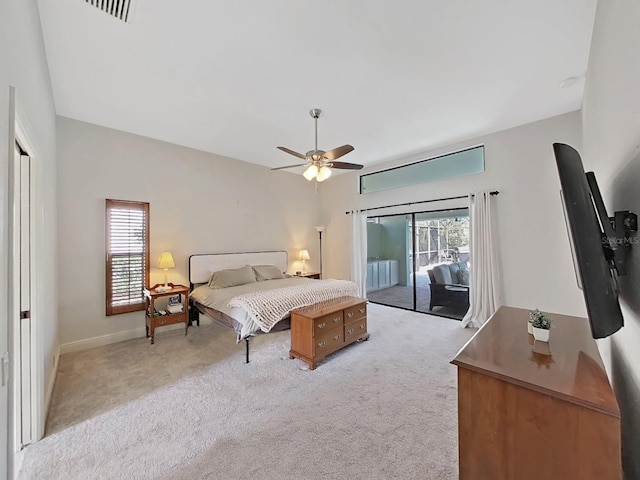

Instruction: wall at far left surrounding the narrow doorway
[0,0,58,470]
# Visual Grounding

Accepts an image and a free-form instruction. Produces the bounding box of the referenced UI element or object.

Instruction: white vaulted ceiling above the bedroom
[38,0,596,172]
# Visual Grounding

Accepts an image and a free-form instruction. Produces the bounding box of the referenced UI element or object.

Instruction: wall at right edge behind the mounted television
[582,0,640,479]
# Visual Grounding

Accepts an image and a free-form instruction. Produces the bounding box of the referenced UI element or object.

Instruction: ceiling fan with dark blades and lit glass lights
[271,108,363,182]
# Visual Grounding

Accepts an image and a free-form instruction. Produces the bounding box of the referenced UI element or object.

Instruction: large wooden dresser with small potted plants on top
[452,307,622,480]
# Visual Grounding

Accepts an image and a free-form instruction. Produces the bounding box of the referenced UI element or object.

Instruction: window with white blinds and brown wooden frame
[106,199,149,315]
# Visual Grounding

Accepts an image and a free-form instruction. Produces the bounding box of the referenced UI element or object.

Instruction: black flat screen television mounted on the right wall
[553,143,624,338]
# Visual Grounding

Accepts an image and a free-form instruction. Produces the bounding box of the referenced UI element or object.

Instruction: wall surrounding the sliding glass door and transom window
[320,112,586,315]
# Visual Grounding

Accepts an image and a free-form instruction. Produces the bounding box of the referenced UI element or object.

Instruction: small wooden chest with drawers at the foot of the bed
[289,297,369,370]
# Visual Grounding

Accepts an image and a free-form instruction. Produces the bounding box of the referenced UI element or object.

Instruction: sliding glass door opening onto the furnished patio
[367,209,469,319]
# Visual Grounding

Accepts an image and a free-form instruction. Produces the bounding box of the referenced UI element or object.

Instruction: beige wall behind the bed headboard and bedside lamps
[57,117,319,351]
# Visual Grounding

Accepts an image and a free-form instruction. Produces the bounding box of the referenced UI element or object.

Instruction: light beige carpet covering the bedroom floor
[18,305,474,480]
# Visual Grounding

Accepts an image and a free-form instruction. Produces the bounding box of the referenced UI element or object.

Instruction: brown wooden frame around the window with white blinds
[105,198,150,316]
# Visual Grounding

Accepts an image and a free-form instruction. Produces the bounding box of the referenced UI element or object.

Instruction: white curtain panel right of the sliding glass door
[462,191,500,327]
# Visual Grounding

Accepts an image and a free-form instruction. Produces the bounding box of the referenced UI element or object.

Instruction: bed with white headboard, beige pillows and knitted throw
[189,251,358,363]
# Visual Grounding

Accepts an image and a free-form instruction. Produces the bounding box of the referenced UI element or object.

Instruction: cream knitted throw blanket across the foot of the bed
[228,279,358,333]
